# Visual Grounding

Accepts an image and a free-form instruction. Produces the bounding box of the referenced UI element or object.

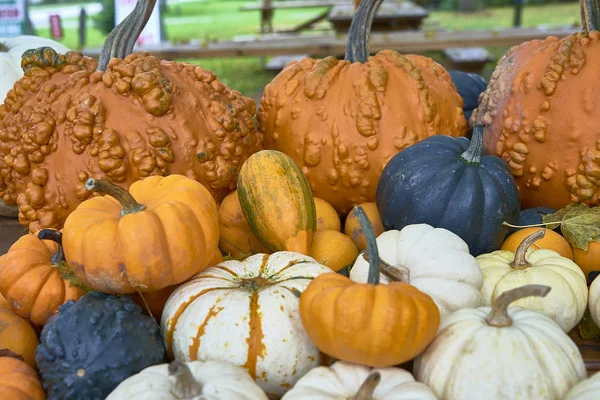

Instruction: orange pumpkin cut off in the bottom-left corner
[0,349,46,400]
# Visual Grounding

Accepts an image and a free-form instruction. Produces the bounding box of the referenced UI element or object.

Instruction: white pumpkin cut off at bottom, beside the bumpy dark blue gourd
[106,361,268,400]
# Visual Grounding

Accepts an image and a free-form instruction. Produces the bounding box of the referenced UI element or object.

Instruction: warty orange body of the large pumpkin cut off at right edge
[470,31,600,209]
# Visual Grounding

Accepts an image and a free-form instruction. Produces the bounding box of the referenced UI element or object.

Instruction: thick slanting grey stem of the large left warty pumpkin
[98,0,156,71]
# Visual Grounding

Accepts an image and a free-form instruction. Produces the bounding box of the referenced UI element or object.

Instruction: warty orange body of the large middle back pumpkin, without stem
[257,50,466,214]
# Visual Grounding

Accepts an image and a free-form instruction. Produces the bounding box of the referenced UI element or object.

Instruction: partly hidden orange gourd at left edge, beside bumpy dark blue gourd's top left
[0,309,40,368]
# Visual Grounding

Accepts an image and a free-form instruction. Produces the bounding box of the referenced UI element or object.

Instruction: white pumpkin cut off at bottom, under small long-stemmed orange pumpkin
[281,361,437,400]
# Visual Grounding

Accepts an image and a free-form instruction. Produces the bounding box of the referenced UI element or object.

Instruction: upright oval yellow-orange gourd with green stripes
[238,150,317,254]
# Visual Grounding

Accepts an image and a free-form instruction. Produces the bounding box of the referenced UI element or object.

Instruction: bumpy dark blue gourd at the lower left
[36,292,165,400]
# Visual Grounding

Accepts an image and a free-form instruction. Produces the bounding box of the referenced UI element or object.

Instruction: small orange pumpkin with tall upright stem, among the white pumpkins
[300,207,440,368]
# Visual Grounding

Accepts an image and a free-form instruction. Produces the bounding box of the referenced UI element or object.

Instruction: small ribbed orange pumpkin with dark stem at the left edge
[0,229,84,326]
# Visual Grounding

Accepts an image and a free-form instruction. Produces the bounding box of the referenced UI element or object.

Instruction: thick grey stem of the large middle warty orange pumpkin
[344,0,383,63]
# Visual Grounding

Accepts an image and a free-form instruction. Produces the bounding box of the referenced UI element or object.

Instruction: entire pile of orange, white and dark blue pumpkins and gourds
[0,0,600,400]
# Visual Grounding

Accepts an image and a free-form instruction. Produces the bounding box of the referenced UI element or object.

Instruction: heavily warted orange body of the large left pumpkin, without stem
[0,49,262,232]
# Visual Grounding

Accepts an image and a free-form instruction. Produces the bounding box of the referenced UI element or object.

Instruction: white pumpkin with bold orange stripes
[161,251,333,397]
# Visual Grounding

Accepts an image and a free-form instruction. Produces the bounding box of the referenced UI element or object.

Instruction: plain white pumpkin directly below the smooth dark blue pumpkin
[350,224,482,320]
